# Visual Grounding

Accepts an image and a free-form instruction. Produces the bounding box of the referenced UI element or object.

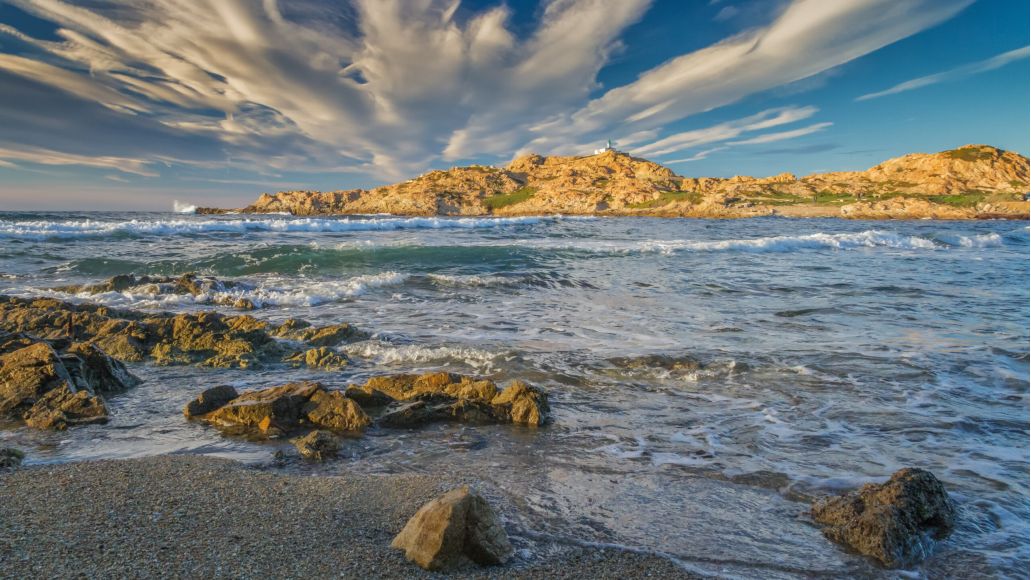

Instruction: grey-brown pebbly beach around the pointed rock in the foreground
[0,455,697,578]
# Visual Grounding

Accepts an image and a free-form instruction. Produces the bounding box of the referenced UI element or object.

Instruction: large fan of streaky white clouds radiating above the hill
[0,0,970,178]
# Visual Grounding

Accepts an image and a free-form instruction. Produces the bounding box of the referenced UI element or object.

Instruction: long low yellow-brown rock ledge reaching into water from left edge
[0,296,365,370]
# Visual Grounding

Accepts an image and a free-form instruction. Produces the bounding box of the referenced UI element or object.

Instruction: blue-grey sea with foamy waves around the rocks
[0,208,1029,578]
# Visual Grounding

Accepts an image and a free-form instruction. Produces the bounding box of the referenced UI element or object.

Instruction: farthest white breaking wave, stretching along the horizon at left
[0,217,555,239]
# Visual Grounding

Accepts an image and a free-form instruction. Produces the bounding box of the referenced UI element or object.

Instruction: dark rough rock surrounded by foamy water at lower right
[812,468,956,568]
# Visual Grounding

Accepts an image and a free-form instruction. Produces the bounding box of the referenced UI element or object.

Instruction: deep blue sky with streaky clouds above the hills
[0,0,1031,211]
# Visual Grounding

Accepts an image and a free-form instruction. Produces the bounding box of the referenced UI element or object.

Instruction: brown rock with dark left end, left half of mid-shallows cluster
[182,382,370,438]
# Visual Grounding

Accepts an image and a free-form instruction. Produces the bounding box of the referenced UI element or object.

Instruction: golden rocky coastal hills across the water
[197,145,1029,219]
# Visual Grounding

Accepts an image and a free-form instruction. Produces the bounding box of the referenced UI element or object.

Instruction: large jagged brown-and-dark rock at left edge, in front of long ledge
[0,334,139,430]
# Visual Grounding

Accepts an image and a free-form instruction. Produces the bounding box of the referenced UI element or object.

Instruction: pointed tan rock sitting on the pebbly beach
[391,486,512,570]
